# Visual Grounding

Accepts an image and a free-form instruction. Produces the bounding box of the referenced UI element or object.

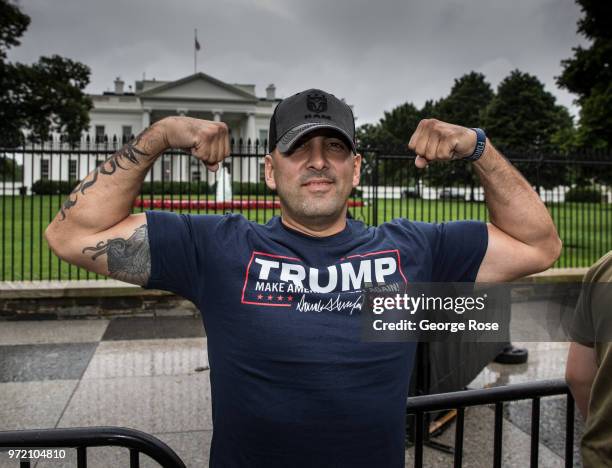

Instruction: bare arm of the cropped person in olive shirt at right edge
[565,343,597,419]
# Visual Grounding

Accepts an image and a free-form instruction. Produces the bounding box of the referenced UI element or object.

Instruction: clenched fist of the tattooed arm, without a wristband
[159,117,230,172]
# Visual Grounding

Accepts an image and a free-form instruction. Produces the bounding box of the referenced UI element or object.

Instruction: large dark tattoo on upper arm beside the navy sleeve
[83,224,151,285]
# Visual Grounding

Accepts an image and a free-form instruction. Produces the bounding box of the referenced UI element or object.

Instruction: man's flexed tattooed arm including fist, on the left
[45,117,230,285]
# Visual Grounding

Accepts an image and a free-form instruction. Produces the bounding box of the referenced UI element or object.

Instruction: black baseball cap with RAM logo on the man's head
[268,89,357,153]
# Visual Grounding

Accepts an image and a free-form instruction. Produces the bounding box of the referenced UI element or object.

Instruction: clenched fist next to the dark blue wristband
[408,119,476,169]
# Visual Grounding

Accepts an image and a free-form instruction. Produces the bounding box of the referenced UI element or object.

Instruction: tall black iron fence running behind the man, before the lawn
[0,140,612,281]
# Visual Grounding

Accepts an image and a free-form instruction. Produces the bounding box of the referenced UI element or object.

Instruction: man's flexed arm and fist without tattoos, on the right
[408,119,561,282]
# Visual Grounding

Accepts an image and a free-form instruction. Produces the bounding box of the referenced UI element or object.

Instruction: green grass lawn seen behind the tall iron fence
[0,195,612,281]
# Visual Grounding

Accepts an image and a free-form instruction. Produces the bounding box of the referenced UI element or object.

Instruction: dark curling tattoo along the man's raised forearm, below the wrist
[60,127,160,221]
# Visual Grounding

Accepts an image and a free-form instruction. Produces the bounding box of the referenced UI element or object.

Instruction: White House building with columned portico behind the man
[23,72,280,189]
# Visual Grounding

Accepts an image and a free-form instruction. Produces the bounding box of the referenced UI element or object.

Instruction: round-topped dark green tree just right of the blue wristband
[483,70,573,187]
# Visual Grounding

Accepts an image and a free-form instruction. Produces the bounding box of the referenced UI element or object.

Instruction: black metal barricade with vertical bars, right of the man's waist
[406,380,574,468]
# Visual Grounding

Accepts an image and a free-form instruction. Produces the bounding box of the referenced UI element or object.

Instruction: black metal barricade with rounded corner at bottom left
[0,427,185,468]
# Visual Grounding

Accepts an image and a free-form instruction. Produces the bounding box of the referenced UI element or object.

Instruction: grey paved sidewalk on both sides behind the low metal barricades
[0,317,581,468]
